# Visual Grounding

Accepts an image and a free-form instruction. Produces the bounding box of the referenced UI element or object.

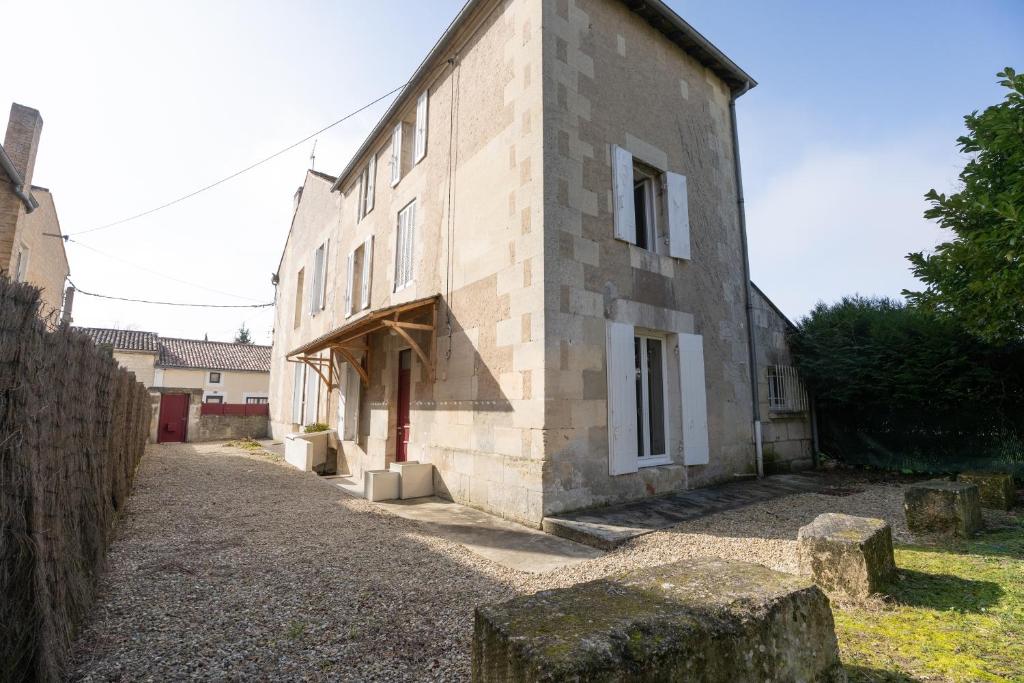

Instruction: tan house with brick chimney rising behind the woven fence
[0,103,70,318]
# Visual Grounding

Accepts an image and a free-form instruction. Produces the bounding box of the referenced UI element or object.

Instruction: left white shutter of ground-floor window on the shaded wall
[605,321,638,475]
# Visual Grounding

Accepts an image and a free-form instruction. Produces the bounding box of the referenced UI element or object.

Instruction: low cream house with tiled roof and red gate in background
[76,328,270,442]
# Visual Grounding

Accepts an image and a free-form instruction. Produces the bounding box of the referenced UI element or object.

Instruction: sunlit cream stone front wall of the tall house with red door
[271,0,545,524]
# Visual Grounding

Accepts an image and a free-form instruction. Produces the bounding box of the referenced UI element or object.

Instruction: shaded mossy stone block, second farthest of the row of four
[903,479,984,537]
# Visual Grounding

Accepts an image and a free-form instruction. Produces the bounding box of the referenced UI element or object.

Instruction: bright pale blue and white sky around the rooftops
[0,0,1024,343]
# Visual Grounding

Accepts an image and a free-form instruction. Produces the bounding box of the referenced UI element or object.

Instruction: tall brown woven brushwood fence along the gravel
[0,278,150,681]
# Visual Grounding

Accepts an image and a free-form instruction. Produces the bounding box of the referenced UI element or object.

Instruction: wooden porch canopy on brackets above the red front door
[287,294,440,389]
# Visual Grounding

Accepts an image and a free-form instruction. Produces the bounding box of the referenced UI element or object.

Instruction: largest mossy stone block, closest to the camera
[473,559,846,683]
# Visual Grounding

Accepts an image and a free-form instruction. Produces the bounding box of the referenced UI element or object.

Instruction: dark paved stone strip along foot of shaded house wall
[542,474,825,550]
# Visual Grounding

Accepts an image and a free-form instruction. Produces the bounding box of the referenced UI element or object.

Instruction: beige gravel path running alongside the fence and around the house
[66,444,958,681]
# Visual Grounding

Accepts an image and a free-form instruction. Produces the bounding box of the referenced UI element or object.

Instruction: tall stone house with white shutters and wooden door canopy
[270,0,809,525]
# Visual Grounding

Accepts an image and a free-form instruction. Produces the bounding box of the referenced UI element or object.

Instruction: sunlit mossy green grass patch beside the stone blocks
[835,517,1024,682]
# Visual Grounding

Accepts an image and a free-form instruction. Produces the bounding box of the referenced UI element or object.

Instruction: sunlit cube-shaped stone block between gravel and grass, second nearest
[797,512,896,598]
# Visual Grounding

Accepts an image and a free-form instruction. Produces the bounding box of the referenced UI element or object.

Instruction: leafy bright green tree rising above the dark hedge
[903,67,1024,342]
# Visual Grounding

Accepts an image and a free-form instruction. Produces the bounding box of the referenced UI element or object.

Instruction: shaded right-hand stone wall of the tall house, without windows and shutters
[543,0,755,514]
